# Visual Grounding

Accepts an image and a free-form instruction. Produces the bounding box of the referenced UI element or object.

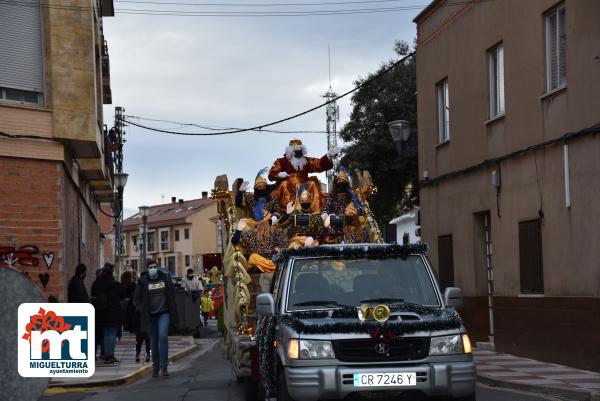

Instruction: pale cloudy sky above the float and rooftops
[104,0,428,217]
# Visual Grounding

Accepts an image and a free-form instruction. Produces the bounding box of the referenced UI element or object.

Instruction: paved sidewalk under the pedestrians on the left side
[46,333,202,394]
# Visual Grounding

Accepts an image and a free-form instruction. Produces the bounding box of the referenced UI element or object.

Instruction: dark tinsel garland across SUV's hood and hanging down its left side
[256,302,462,397]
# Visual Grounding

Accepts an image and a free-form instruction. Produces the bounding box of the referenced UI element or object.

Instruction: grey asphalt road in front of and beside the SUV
[41,327,572,401]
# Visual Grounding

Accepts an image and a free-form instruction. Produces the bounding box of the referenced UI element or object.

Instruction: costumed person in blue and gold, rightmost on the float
[321,166,369,244]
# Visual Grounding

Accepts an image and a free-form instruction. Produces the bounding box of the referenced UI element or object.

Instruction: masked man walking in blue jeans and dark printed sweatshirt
[134,260,178,377]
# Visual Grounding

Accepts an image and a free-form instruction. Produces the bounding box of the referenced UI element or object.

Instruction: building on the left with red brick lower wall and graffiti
[0,1,114,301]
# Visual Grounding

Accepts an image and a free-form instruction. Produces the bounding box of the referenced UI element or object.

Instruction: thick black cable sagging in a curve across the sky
[123,52,415,136]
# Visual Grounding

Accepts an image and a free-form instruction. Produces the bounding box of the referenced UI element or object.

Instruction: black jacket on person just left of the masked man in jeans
[92,276,125,327]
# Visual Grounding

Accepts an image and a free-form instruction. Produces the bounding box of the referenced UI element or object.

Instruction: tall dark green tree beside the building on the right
[340,41,418,224]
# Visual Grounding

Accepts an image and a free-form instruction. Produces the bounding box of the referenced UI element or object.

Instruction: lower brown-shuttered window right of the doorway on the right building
[519,219,544,294]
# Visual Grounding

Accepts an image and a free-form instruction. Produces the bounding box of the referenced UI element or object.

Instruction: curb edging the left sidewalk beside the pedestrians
[44,340,218,395]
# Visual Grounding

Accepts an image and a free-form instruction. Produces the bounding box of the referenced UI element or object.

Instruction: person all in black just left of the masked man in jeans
[92,267,125,364]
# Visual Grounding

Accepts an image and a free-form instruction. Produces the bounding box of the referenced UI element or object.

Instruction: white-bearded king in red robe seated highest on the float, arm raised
[269,139,340,213]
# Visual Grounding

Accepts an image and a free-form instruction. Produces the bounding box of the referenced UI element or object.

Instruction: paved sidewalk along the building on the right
[473,348,600,401]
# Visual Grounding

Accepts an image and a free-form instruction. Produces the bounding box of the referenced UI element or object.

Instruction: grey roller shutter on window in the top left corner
[0,0,44,93]
